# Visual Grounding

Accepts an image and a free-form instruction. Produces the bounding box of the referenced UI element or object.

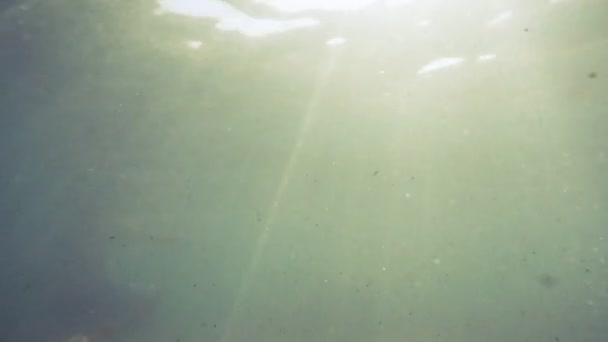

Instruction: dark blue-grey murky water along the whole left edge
[0,0,156,342]
